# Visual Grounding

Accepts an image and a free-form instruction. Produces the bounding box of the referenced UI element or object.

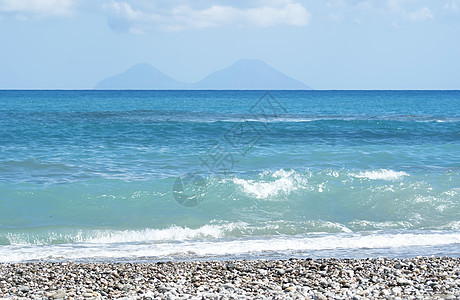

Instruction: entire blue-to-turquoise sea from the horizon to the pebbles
[0,91,460,262]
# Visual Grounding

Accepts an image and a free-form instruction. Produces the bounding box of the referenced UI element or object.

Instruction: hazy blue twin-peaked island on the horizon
[95,59,311,90]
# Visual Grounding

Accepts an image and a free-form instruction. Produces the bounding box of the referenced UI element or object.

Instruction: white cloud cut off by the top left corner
[0,0,75,20]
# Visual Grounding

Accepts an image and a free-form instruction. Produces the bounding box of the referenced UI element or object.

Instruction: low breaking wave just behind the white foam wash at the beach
[4,219,460,249]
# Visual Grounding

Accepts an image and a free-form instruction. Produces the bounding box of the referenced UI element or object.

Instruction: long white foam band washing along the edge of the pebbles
[0,231,460,262]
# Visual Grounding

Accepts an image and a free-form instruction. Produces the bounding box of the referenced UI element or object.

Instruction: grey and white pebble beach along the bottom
[0,257,460,299]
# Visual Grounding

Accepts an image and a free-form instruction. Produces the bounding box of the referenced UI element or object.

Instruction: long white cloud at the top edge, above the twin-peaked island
[104,0,311,33]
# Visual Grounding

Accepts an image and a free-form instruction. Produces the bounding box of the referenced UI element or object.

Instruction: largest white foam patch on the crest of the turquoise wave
[232,169,306,199]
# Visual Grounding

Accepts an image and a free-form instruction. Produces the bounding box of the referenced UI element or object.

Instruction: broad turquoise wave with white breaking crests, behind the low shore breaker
[0,169,460,233]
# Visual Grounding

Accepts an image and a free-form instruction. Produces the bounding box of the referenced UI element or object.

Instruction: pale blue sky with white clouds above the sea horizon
[0,0,460,89]
